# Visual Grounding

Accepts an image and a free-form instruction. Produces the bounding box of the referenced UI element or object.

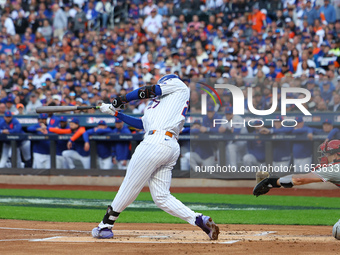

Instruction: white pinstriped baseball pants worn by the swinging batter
[111,133,200,225]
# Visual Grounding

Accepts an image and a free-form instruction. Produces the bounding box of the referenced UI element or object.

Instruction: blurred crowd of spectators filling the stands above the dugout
[0,0,340,114]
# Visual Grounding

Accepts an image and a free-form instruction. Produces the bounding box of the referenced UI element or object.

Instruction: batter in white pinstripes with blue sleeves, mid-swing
[92,74,219,240]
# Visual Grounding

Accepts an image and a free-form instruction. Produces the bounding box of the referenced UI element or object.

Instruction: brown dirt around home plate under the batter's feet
[0,220,340,255]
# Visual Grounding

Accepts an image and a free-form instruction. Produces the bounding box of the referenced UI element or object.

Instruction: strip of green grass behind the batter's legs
[0,189,340,225]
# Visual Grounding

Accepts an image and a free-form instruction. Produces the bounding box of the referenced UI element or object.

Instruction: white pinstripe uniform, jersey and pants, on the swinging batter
[107,78,200,225]
